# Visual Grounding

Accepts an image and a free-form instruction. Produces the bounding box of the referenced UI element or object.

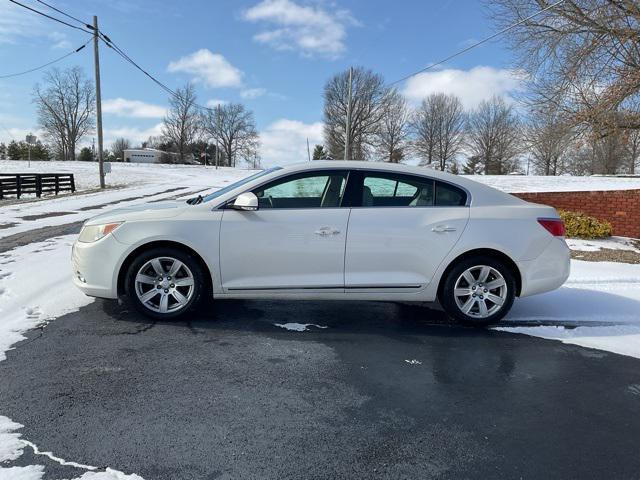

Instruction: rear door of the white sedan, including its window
[345,171,469,292]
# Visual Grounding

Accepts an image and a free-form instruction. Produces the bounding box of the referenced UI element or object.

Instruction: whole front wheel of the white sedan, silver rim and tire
[127,248,204,319]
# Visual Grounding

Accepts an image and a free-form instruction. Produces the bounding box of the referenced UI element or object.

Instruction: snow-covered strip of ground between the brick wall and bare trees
[465,175,640,193]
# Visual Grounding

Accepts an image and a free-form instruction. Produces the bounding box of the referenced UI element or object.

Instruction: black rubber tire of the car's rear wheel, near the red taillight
[439,256,516,326]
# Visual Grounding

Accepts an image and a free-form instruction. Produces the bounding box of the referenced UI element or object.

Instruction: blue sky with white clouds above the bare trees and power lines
[0,0,520,164]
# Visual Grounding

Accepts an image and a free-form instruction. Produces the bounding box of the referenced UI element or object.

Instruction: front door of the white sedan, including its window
[220,170,349,293]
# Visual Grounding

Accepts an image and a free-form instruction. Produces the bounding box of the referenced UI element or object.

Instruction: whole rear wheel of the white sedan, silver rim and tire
[440,256,516,325]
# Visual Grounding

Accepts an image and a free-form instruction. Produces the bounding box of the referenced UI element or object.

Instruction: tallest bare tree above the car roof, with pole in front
[324,67,389,160]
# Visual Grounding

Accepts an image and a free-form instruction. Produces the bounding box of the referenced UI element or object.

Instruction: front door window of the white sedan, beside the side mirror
[253,171,347,208]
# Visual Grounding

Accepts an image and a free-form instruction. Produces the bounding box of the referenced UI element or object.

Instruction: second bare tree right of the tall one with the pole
[411,93,466,171]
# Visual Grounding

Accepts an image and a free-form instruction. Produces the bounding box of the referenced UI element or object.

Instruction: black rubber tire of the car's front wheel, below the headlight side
[125,247,207,320]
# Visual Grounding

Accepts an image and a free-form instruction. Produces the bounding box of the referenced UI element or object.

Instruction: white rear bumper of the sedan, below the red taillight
[517,237,571,297]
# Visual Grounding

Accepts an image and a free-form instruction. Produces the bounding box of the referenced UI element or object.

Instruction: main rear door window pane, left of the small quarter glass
[362,173,434,207]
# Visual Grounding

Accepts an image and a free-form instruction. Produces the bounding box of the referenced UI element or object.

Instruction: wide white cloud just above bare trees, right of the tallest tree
[403,66,523,109]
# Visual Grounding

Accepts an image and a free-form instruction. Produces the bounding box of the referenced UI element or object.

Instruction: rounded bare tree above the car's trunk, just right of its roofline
[468,96,521,175]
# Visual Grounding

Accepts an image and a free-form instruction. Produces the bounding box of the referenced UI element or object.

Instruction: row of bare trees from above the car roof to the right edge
[320,67,640,175]
